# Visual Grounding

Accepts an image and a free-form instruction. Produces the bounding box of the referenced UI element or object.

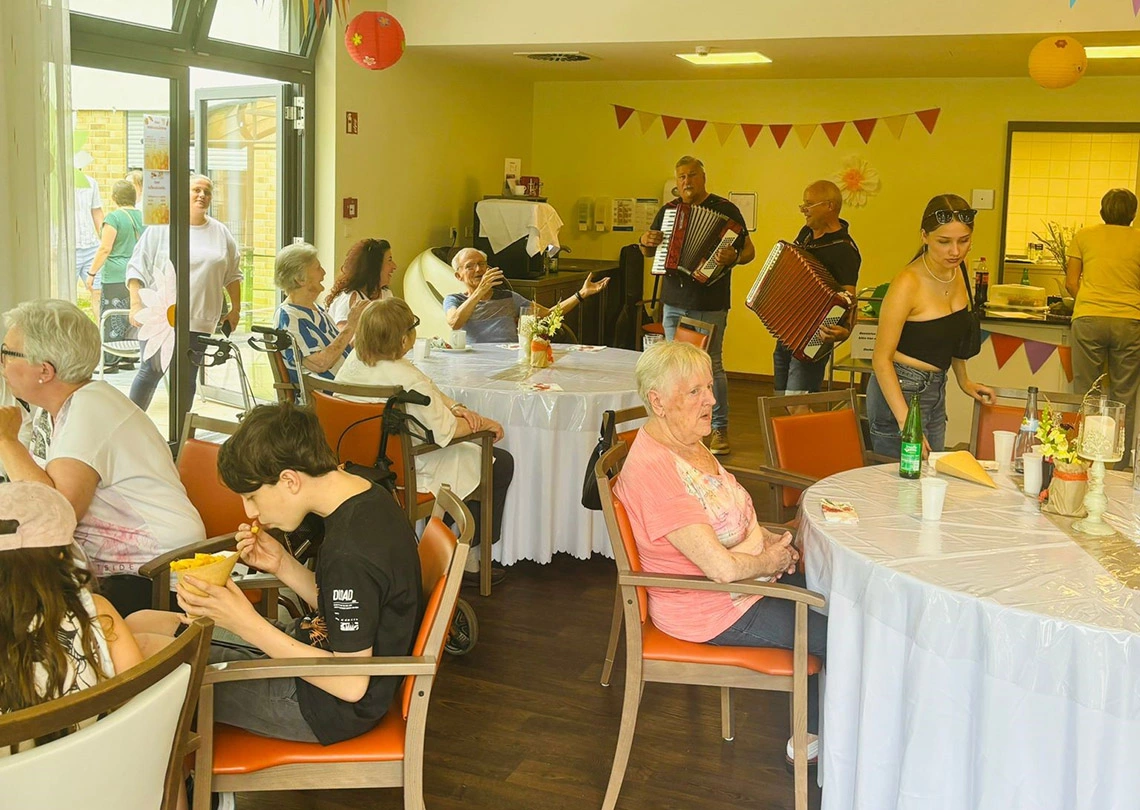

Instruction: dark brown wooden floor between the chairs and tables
[237,381,820,810]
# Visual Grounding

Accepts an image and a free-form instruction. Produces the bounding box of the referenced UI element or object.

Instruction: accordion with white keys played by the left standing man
[652,203,743,284]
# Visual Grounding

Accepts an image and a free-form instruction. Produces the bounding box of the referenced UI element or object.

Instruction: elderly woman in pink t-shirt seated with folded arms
[614,341,828,760]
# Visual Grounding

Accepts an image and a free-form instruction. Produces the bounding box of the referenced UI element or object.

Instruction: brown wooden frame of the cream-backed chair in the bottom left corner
[0,619,213,810]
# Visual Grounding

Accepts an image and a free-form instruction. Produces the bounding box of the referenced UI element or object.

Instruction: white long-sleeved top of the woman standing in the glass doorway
[127,216,242,335]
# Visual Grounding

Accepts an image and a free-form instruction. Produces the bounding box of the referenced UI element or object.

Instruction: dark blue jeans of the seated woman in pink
[709,574,828,734]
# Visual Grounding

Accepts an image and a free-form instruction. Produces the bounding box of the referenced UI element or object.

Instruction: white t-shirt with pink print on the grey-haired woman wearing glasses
[30,382,206,576]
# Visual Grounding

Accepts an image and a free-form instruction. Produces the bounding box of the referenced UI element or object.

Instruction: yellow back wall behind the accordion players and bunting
[532,79,1140,374]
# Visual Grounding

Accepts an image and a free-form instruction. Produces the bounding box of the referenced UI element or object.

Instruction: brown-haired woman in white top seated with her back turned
[336,298,514,582]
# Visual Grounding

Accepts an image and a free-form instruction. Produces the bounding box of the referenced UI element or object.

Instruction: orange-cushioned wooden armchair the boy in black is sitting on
[194,485,472,810]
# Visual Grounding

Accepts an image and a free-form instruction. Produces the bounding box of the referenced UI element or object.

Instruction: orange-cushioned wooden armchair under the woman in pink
[596,444,824,810]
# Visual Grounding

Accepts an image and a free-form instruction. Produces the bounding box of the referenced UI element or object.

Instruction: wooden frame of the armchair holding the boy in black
[194,485,472,810]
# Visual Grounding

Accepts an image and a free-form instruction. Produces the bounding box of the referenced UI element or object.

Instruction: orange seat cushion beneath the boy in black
[214,702,406,775]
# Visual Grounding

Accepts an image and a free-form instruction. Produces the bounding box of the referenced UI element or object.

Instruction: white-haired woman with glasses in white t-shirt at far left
[0,300,205,615]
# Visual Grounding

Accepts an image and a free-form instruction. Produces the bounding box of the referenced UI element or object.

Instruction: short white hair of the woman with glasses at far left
[5,298,103,384]
